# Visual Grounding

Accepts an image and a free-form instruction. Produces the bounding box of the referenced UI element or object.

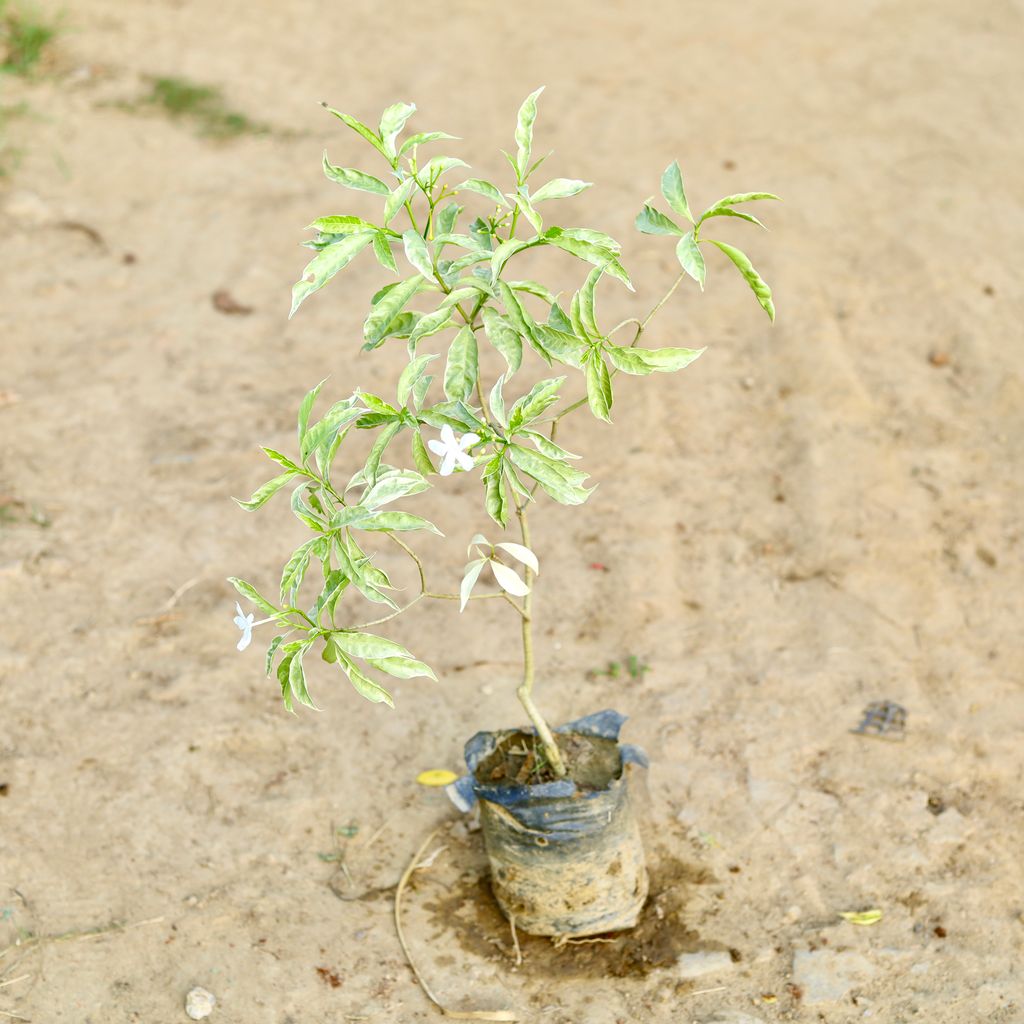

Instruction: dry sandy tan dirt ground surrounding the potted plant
[0,0,1024,1024]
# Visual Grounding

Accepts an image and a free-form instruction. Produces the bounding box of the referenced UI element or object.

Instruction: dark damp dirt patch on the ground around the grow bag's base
[426,856,725,978]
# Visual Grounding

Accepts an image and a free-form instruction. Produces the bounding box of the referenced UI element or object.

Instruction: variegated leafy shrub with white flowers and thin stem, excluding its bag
[230,90,777,777]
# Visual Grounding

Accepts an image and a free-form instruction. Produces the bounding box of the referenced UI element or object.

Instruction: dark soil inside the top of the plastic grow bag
[476,732,623,790]
